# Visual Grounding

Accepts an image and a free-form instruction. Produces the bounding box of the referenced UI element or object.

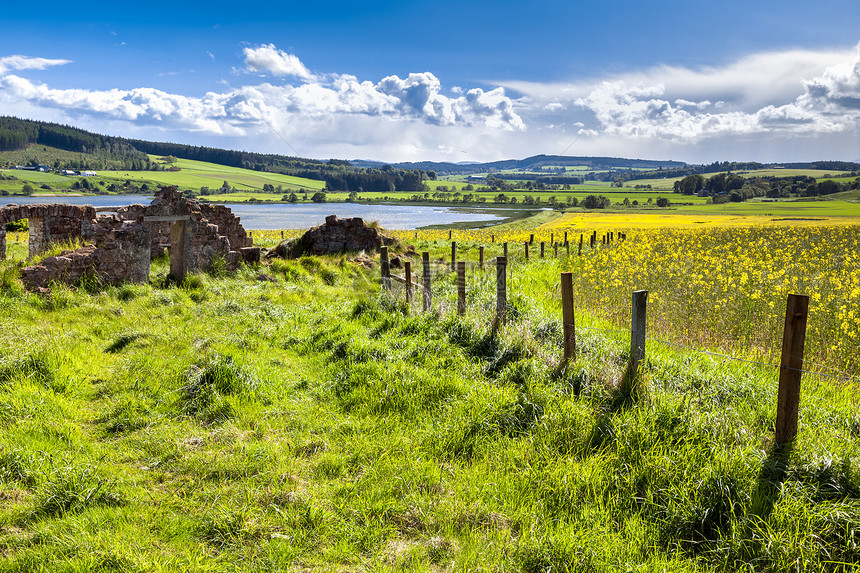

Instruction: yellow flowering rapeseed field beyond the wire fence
[254,213,860,375]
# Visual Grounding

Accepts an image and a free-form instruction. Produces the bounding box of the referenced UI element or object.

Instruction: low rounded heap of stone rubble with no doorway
[268,215,397,258]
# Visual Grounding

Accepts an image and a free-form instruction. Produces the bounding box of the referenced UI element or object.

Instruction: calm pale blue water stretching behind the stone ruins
[0,195,505,230]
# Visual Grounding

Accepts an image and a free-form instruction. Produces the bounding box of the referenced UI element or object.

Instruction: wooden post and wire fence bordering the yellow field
[380,231,860,444]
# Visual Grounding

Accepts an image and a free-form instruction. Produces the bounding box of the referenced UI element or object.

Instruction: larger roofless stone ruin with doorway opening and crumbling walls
[0,187,260,289]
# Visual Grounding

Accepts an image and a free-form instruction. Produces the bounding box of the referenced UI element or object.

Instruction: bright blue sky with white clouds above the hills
[0,0,860,162]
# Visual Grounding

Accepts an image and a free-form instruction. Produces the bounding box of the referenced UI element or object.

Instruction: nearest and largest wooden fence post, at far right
[775,294,809,444]
